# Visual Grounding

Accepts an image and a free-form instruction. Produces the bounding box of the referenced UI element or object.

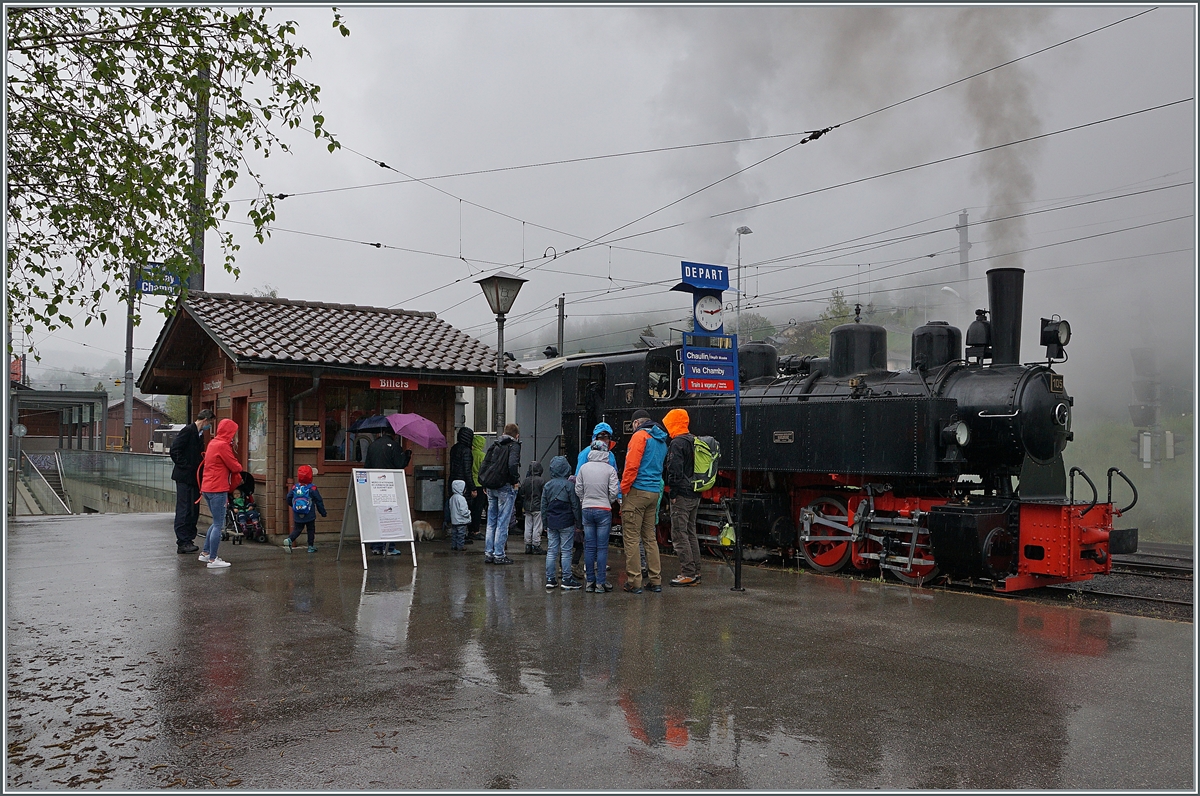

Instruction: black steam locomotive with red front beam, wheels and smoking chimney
[518,268,1138,591]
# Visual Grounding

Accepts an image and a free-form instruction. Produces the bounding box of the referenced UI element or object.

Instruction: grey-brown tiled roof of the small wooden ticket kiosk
[184,291,530,376]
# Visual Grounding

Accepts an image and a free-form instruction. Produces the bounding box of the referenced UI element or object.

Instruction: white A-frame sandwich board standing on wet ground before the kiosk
[337,469,416,569]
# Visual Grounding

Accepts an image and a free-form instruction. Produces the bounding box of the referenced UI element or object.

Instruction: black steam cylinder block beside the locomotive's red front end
[929,501,1020,580]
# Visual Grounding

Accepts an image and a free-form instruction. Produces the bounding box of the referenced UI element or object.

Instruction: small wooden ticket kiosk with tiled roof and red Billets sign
[137,292,533,538]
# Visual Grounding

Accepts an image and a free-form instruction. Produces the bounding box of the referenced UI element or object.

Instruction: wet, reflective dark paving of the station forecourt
[5,514,1195,790]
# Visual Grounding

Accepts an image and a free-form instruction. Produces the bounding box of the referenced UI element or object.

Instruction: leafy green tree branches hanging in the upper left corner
[5,6,349,352]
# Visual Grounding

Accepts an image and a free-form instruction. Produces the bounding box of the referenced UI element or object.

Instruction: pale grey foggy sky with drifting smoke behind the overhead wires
[23,6,1196,420]
